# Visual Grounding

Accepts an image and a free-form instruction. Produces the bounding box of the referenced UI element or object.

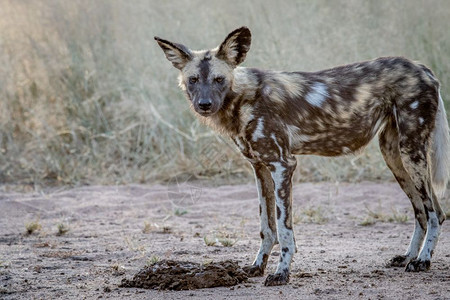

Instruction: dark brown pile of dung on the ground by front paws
[120,260,248,291]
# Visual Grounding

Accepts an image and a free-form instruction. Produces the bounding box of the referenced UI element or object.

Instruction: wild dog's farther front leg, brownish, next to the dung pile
[244,162,277,277]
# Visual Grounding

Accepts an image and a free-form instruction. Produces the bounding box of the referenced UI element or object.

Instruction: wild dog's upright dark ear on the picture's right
[216,27,252,67]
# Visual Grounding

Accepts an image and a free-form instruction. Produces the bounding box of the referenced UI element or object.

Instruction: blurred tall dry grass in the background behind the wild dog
[0,0,450,185]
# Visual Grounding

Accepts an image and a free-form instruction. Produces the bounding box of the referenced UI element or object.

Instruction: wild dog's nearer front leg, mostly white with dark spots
[264,157,297,286]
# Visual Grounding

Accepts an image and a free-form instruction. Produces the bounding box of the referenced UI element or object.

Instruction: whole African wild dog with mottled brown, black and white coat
[155,27,449,285]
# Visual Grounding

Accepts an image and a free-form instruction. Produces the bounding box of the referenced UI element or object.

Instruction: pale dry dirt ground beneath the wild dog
[0,182,450,299]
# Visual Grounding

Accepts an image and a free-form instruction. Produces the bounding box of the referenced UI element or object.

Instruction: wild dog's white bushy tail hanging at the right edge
[431,92,450,197]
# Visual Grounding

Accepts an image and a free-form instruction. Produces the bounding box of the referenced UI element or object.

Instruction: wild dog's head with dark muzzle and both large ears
[155,27,251,117]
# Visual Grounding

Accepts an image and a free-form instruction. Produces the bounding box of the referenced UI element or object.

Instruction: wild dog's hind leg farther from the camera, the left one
[379,118,427,267]
